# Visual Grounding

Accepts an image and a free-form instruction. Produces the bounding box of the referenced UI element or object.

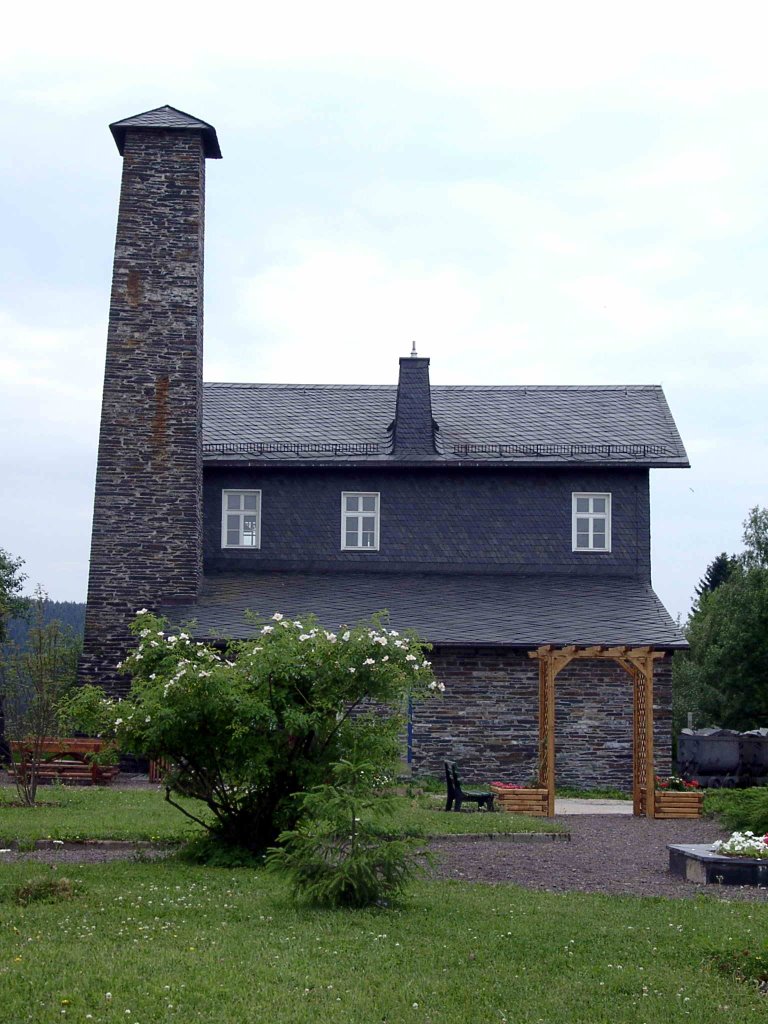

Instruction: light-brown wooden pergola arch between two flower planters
[528,644,665,818]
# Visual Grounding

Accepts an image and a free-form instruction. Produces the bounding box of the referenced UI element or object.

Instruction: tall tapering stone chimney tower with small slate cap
[80,106,221,693]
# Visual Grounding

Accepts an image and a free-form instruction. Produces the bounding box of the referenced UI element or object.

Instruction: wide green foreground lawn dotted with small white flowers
[0,861,768,1024]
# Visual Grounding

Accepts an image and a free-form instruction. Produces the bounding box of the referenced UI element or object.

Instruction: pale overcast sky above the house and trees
[0,0,768,616]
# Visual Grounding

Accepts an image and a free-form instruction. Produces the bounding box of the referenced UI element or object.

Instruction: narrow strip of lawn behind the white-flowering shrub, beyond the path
[0,785,561,846]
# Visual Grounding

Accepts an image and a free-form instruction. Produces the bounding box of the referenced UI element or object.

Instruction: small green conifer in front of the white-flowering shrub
[267,761,427,907]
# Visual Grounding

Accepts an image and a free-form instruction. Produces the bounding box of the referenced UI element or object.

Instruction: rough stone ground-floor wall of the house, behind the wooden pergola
[413,647,672,791]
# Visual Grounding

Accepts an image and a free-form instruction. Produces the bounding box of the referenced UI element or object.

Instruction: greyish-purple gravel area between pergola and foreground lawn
[432,814,768,902]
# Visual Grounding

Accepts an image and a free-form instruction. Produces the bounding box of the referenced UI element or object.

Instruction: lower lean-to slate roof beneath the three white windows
[162,572,687,648]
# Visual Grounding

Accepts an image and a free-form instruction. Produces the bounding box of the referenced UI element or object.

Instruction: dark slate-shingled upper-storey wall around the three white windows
[204,466,650,580]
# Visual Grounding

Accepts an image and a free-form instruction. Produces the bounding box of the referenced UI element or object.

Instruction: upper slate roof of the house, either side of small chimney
[203,383,688,466]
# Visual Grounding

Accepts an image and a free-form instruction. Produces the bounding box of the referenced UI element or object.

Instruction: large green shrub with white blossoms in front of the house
[82,610,442,851]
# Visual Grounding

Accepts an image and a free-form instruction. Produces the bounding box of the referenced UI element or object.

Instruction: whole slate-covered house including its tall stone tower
[82,106,688,786]
